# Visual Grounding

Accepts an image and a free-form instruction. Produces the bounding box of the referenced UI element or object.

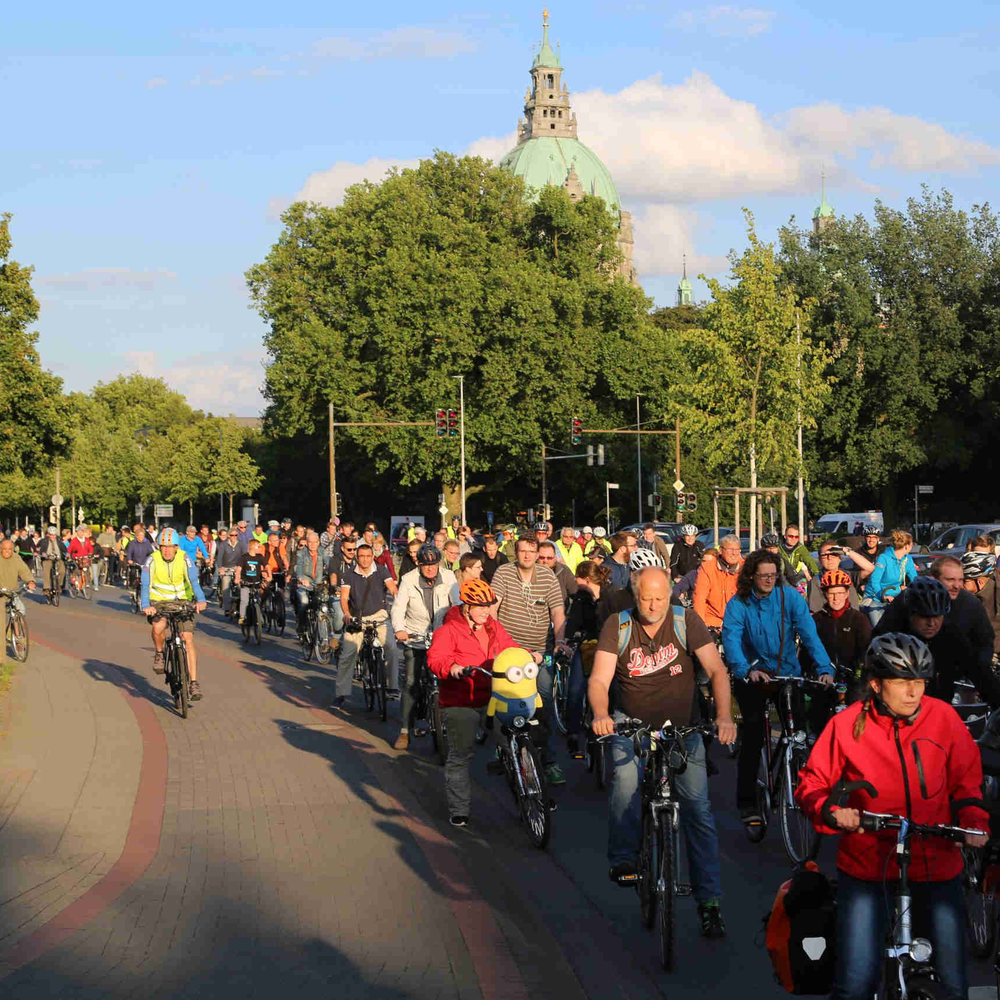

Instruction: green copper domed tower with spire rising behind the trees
[500,10,638,284]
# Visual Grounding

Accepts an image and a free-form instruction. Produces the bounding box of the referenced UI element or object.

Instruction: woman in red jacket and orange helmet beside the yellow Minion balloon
[427,580,517,826]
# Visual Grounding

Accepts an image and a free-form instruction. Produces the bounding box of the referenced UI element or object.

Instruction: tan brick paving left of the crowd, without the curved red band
[0,595,582,1000]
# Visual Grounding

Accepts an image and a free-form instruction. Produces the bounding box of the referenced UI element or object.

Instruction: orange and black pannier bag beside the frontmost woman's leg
[764,861,837,994]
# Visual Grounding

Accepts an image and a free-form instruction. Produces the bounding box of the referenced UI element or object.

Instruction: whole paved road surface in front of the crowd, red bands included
[0,588,995,1000]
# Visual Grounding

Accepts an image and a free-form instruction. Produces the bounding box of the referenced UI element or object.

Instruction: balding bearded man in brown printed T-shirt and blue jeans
[587,568,736,938]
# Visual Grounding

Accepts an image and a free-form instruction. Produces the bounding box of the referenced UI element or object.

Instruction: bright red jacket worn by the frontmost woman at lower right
[795,695,989,882]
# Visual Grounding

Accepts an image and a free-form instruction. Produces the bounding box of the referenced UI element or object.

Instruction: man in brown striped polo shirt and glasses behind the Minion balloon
[493,535,566,785]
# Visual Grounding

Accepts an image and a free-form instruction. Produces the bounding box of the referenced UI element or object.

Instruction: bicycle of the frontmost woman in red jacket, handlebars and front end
[823,781,985,1000]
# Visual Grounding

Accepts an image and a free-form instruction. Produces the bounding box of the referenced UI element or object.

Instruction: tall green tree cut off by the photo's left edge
[0,212,69,475]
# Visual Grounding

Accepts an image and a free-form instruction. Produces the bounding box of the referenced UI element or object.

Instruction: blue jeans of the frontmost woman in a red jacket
[830,872,968,1000]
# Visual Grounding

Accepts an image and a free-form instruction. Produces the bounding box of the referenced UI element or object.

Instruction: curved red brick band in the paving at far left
[0,640,167,978]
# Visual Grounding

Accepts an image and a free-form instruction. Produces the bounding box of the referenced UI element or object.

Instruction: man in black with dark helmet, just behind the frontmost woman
[875,576,1000,708]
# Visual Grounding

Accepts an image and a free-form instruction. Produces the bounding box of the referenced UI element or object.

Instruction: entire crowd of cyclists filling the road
[12,518,1000,997]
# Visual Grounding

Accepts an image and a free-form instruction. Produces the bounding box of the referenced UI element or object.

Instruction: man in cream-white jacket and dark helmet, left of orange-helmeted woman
[392,545,458,750]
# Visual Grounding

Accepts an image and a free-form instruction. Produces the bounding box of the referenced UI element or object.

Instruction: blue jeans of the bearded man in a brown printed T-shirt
[604,716,722,903]
